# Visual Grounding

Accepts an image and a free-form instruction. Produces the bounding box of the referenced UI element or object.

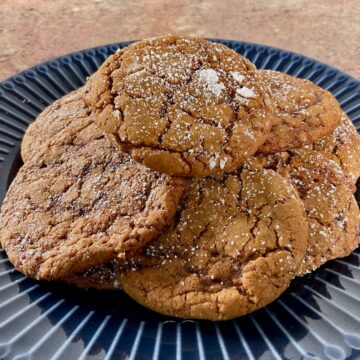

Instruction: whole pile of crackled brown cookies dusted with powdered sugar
[0,36,360,320]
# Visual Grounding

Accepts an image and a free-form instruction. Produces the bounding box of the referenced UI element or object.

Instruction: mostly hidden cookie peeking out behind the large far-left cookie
[21,87,90,162]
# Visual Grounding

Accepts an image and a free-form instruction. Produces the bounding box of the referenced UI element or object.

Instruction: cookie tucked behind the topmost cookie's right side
[258,70,341,154]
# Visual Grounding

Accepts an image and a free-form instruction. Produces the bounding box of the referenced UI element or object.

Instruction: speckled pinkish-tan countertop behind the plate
[0,0,360,80]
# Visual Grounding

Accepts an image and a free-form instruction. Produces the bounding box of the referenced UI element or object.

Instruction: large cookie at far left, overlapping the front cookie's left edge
[0,107,183,280]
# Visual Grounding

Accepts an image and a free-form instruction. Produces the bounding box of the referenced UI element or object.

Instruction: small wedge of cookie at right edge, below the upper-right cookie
[309,112,360,184]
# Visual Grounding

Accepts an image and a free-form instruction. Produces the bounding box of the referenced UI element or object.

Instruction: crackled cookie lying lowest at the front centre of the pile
[119,169,307,320]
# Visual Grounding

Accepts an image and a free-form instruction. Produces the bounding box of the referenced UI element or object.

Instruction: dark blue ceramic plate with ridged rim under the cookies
[0,40,360,360]
